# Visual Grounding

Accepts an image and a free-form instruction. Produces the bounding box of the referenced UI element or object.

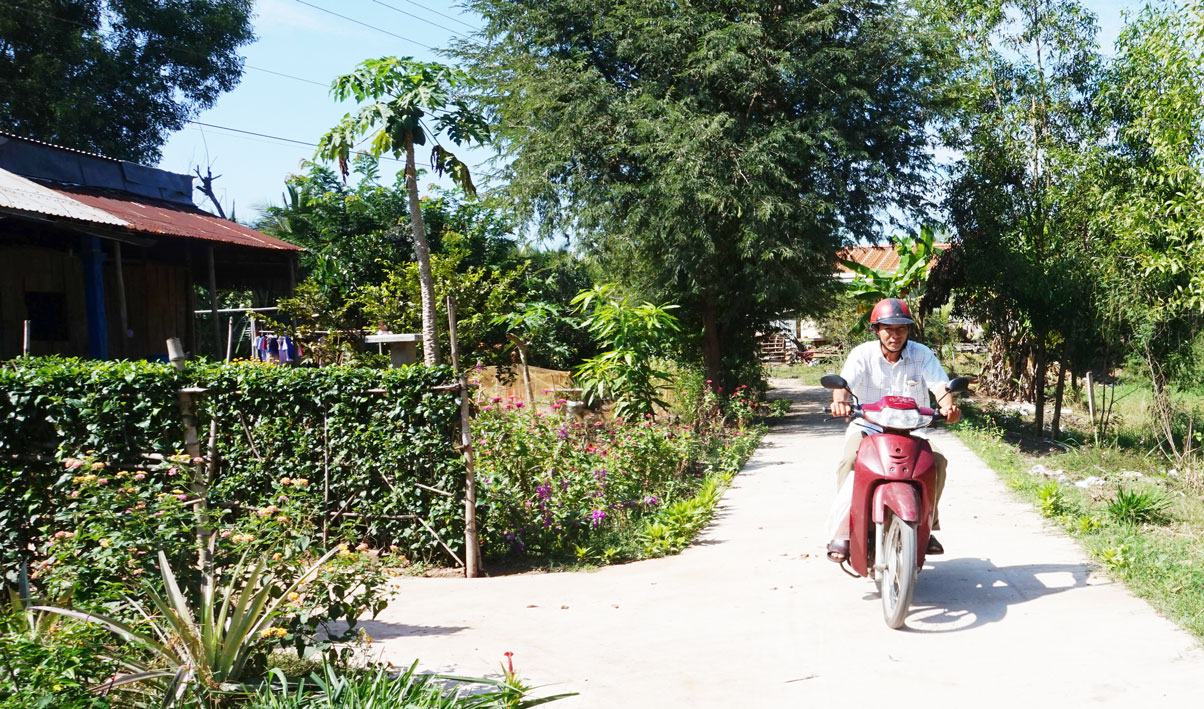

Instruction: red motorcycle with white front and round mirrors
[820,374,969,628]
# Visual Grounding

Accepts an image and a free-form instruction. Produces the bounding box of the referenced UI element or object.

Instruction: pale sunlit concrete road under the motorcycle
[367,383,1204,709]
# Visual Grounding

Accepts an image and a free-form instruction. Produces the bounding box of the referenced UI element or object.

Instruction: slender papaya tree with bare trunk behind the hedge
[318,57,488,365]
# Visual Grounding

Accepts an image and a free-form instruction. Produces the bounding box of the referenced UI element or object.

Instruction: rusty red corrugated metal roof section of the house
[46,184,305,252]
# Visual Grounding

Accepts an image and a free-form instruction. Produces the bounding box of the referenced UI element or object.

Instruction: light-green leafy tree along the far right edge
[1096,2,1204,467]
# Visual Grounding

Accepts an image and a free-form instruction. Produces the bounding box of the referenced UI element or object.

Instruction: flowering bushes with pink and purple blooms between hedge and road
[473,387,760,563]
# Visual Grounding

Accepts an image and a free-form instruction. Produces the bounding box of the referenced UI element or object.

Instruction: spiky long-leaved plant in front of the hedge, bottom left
[30,548,338,707]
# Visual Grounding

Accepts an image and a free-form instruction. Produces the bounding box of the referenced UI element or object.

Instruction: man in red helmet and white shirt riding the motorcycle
[828,297,962,562]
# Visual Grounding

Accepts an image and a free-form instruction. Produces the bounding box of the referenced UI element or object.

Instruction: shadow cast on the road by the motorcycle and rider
[895,559,1093,633]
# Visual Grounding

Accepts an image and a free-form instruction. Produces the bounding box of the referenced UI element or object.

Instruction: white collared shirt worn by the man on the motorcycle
[840,339,949,438]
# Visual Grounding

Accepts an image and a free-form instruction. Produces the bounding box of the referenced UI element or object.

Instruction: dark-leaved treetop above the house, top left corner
[0,0,255,164]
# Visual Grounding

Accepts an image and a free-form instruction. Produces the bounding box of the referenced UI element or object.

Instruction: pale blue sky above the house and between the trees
[159,0,1141,221]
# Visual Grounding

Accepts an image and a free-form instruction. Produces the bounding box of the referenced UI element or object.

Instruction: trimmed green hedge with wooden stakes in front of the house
[0,359,464,583]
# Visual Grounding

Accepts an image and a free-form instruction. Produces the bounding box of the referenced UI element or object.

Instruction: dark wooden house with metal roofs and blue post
[0,132,303,359]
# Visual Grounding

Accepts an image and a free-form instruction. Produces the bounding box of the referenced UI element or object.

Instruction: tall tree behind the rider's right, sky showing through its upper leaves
[926,0,1100,435]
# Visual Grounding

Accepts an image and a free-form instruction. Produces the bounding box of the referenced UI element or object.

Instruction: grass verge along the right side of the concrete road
[956,410,1204,642]
